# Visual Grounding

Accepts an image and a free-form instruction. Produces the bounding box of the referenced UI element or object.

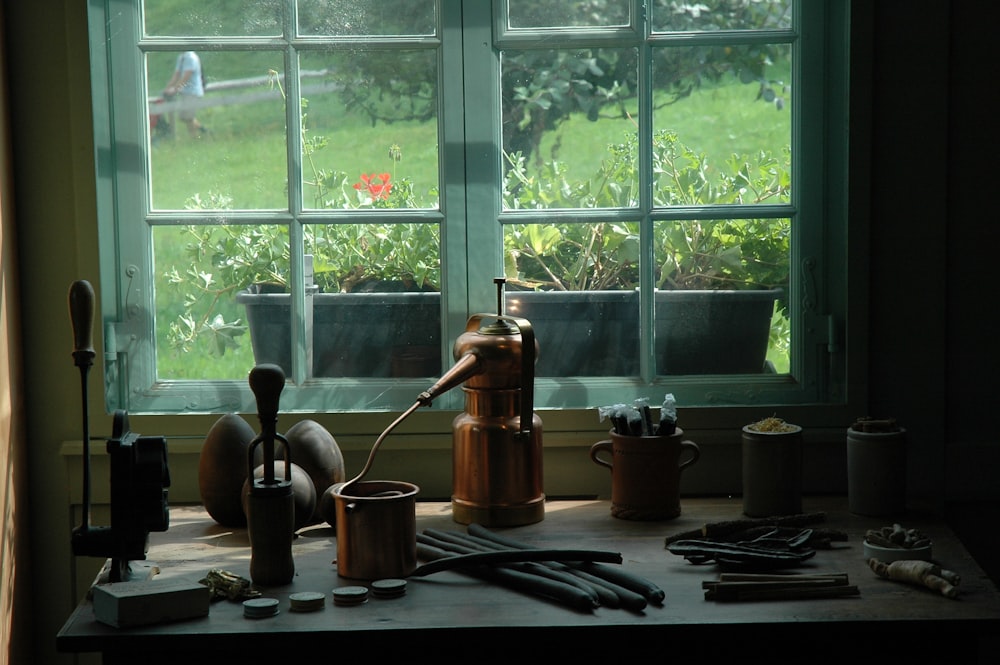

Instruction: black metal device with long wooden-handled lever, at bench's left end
[69,280,170,582]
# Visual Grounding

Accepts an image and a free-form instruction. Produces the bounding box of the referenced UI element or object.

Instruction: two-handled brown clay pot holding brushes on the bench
[590,428,701,520]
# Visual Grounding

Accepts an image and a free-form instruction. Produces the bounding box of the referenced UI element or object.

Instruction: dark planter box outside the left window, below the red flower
[236,290,441,377]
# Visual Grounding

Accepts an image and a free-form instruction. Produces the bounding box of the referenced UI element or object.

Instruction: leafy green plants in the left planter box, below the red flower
[165,187,441,355]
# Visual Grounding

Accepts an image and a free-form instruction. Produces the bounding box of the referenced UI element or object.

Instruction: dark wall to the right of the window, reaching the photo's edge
[864,0,1000,500]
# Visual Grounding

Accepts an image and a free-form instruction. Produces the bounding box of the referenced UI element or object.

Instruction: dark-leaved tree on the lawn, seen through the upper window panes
[310,0,791,159]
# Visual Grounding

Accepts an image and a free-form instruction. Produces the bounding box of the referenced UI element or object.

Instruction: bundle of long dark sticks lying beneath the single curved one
[414,524,665,612]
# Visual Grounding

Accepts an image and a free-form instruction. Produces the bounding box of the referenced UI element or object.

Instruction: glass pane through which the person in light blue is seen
[146,51,288,210]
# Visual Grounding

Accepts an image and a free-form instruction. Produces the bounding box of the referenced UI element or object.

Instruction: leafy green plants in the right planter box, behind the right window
[504,131,791,290]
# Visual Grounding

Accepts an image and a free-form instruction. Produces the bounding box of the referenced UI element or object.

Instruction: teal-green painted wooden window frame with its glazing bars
[90,0,861,415]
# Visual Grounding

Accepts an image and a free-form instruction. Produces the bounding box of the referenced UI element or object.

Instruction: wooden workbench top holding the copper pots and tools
[57,497,1000,665]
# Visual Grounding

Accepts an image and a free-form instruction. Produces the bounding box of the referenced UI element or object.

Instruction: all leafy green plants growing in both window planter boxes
[162,124,791,355]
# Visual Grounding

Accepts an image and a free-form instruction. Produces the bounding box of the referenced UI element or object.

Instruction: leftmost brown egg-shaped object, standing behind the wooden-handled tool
[198,413,263,527]
